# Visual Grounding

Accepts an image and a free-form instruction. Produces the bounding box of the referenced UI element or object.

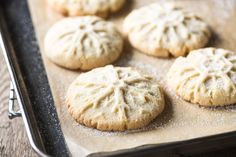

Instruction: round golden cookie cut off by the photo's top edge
[47,0,125,17]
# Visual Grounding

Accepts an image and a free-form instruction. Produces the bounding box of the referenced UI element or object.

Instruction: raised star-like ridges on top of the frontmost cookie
[76,66,153,120]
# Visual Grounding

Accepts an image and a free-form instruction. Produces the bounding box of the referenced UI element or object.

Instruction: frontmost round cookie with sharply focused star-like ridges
[66,65,164,131]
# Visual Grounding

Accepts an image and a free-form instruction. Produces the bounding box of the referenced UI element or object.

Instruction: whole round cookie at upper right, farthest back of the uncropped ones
[123,3,210,57]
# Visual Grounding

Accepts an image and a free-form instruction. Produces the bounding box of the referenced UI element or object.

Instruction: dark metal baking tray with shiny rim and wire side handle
[0,0,236,157]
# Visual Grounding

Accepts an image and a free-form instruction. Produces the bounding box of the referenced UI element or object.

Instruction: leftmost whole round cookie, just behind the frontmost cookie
[44,16,123,70]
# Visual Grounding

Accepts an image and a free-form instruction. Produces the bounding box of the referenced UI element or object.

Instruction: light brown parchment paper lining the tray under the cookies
[26,0,236,156]
